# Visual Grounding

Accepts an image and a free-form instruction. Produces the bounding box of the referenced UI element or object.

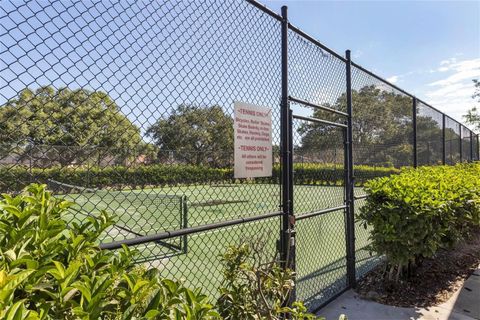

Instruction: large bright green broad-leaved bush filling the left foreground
[0,185,218,320]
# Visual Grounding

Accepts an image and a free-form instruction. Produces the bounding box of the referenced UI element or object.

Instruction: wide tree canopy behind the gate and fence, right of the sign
[296,86,462,167]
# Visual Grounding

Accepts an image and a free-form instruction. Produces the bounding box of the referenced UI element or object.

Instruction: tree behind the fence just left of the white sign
[147,104,233,167]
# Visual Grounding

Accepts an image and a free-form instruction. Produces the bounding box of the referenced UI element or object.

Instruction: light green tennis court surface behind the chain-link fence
[61,184,376,304]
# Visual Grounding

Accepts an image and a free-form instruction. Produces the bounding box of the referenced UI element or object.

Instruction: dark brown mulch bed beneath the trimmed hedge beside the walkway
[356,232,480,307]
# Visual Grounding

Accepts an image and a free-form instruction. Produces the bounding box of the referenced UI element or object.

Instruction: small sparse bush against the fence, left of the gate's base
[217,242,317,320]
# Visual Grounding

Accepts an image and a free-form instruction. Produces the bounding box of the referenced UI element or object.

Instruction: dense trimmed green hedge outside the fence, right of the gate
[358,164,480,281]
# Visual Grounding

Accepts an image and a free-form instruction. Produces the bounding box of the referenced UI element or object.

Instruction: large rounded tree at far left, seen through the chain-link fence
[0,86,142,165]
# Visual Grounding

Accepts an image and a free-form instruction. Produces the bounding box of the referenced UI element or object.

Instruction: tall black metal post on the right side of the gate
[345,50,356,288]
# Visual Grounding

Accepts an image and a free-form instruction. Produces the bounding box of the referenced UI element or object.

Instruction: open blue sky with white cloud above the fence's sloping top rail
[261,0,480,122]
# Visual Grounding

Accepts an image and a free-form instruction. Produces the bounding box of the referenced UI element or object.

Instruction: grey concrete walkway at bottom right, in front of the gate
[318,266,480,320]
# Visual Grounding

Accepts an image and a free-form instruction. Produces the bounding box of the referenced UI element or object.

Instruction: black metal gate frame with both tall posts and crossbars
[279,6,356,303]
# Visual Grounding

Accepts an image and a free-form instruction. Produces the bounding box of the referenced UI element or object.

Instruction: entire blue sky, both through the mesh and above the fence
[0,0,480,132]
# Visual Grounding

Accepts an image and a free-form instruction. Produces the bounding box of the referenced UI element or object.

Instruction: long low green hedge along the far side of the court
[0,164,399,192]
